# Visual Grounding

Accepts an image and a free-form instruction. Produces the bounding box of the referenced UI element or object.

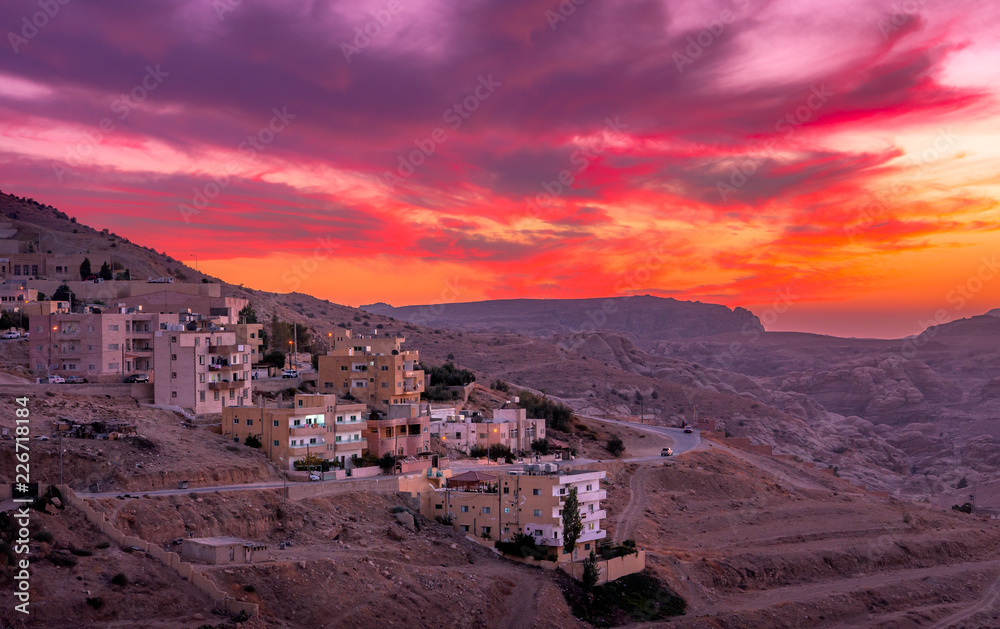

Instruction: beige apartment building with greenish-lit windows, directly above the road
[222,394,367,470]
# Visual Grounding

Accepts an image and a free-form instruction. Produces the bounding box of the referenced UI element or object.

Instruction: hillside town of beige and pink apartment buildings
[0,217,645,608]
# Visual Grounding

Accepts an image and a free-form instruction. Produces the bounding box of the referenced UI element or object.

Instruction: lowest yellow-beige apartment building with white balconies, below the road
[420,465,607,556]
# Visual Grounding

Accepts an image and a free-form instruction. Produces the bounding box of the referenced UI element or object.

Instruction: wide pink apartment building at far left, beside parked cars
[29,309,178,381]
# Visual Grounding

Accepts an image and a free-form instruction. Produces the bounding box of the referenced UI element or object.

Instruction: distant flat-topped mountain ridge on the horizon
[361,295,764,347]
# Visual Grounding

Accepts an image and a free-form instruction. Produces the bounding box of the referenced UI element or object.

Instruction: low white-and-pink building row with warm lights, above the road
[431,408,545,454]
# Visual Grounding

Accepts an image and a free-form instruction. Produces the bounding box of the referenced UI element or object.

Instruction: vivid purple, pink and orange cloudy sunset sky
[0,0,1000,337]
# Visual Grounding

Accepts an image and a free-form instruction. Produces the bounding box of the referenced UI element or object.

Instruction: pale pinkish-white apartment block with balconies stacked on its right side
[151,324,252,415]
